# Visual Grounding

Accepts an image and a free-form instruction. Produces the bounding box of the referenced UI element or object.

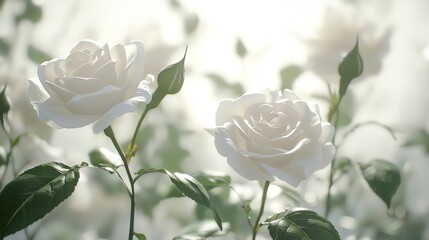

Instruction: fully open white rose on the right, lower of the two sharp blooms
[211,90,335,186]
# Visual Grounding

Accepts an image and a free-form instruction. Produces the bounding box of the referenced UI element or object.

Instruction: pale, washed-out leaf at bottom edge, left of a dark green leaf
[173,221,230,240]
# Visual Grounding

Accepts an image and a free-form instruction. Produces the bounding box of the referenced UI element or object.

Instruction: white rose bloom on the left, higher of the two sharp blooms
[28,40,153,133]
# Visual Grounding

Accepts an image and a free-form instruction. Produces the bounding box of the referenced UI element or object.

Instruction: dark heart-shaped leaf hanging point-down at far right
[360,159,401,208]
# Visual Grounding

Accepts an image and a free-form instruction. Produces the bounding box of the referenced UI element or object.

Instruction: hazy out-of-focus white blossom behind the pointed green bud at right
[302,4,391,83]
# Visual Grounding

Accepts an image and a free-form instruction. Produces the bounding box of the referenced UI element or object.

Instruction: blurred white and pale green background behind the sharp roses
[0,0,429,240]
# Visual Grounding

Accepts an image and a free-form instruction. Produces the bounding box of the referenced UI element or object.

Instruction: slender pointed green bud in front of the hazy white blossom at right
[338,39,363,98]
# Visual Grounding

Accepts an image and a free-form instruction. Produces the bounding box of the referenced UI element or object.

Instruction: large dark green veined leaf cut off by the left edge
[0,162,80,239]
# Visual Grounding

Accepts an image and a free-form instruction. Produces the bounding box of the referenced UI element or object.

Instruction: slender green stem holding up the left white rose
[104,126,135,240]
